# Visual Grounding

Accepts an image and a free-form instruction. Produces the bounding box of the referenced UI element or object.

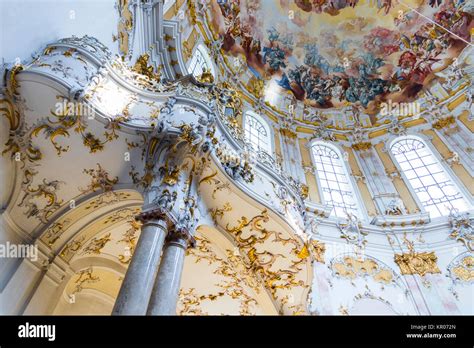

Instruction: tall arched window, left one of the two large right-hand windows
[312,143,360,217]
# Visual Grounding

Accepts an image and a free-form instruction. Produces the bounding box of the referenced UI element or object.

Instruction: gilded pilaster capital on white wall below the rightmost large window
[394,235,441,277]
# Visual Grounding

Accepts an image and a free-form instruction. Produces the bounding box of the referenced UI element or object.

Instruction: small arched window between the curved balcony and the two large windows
[244,111,272,155]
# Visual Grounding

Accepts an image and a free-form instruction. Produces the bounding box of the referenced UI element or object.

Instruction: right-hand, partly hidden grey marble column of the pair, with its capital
[147,231,194,315]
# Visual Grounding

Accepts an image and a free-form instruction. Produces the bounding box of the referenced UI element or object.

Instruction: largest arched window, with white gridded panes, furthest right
[390,137,468,217]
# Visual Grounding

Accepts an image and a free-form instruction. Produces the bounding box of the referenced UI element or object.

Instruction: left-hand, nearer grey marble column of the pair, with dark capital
[112,211,168,315]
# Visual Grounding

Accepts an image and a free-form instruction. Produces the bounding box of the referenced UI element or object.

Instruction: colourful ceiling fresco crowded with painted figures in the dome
[209,0,474,114]
